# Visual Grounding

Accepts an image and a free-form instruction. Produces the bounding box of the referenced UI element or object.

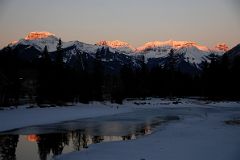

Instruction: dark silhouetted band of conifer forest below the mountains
[0,40,240,106]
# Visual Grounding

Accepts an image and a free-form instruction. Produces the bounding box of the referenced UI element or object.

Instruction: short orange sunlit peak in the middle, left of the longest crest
[96,40,136,52]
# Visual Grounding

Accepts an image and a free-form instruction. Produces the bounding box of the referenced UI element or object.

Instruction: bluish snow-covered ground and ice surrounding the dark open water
[0,99,240,160]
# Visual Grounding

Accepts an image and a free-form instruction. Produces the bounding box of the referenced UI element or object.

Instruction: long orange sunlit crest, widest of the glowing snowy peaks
[137,40,209,52]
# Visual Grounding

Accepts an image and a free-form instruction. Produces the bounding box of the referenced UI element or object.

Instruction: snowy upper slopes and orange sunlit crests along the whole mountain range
[10,32,223,64]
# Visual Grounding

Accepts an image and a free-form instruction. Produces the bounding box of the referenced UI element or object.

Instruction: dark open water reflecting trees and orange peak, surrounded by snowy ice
[0,112,179,160]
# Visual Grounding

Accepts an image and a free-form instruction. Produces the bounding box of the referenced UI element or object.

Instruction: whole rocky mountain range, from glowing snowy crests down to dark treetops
[1,32,231,73]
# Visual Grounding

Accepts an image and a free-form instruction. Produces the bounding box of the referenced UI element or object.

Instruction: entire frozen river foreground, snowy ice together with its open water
[0,100,240,160]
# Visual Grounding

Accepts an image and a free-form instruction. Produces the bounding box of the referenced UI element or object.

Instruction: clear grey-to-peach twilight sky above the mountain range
[0,0,240,48]
